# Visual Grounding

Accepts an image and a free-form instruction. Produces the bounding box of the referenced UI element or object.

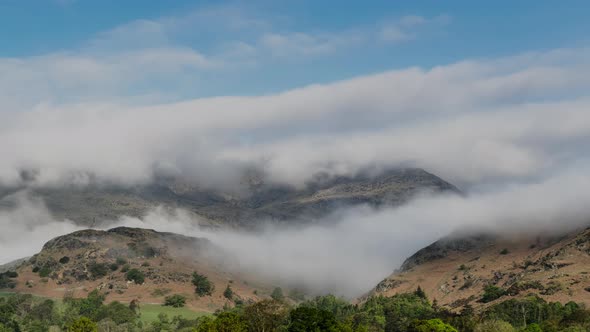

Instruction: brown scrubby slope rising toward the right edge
[370,229,590,310]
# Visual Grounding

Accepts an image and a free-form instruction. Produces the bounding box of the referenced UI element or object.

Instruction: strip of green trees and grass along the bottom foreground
[0,290,590,332]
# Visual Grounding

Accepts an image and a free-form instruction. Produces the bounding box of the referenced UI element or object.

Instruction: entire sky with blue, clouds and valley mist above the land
[0,0,590,296]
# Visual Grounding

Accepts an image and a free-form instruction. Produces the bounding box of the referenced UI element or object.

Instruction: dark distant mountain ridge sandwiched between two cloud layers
[0,168,458,229]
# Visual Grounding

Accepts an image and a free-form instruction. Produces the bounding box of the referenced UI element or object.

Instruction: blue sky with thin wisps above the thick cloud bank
[0,0,590,99]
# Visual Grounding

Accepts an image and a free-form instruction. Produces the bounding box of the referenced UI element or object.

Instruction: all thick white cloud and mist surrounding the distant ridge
[0,45,590,297]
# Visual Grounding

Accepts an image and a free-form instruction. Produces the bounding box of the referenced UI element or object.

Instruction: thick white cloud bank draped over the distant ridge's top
[0,49,590,188]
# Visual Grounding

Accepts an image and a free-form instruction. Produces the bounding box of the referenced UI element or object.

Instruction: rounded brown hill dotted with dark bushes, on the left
[2,227,280,312]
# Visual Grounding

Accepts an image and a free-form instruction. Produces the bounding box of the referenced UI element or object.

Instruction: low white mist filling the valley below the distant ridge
[0,164,590,297]
